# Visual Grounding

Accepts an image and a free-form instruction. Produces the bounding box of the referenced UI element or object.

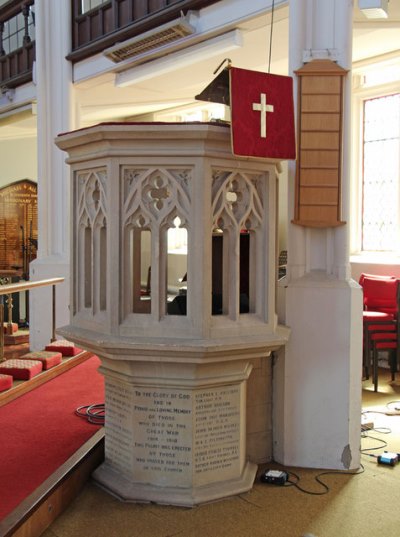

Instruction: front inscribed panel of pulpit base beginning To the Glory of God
[134,387,192,485]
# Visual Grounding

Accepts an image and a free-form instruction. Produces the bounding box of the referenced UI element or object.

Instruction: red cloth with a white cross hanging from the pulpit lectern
[229,67,296,160]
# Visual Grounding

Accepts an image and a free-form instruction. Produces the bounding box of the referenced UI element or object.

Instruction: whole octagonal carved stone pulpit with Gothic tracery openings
[56,123,288,506]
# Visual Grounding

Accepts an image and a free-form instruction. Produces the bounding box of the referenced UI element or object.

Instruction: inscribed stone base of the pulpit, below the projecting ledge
[88,355,257,507]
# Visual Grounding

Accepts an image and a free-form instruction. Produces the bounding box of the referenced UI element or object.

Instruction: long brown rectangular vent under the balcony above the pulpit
[103,18,196,63]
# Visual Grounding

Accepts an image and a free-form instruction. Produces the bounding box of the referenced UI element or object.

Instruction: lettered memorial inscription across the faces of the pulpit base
[106,379,242,487]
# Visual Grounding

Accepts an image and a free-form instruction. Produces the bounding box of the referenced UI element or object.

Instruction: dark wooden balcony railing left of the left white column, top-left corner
[0,0,35,92]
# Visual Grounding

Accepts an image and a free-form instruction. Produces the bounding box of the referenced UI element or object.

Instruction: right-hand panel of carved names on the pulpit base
[194,385,240,477]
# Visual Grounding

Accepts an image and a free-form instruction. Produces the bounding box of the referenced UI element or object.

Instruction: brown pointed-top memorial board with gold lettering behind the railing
[0,179,38,277]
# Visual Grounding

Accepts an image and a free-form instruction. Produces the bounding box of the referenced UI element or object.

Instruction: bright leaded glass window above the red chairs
[362,94,400,252]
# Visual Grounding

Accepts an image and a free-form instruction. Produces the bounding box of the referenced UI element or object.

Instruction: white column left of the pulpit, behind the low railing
[30,0,74,350]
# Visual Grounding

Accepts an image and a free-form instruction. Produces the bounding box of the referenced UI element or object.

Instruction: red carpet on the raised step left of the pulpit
[0,356,104,520]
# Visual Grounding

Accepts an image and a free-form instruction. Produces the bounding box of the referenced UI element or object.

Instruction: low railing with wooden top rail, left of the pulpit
[0,278,64,363]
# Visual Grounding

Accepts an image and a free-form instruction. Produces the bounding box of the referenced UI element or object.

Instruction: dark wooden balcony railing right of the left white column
[68,0,218,62]
